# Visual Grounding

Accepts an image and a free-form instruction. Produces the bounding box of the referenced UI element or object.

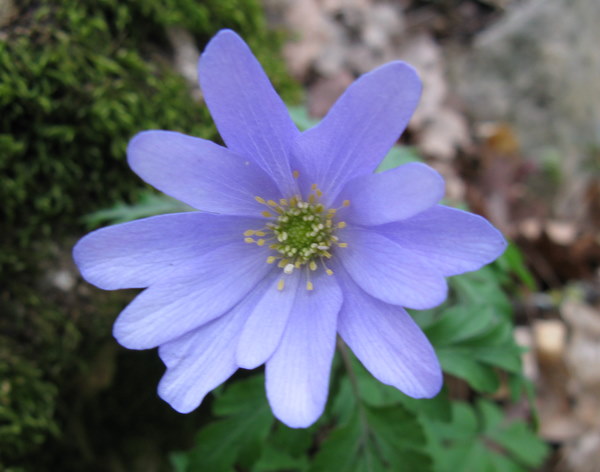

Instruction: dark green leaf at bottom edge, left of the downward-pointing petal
[178,375,275,472]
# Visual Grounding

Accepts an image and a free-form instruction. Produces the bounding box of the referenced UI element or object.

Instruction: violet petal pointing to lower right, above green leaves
[338,276,443,398]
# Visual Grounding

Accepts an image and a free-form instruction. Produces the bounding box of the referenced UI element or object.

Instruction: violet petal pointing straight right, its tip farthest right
[373,205,506,276]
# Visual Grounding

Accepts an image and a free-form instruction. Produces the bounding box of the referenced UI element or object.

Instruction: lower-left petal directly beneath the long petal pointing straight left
[113,242,272,349]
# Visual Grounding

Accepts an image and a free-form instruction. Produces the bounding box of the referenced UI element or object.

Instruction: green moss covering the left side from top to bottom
[0,0,299,470]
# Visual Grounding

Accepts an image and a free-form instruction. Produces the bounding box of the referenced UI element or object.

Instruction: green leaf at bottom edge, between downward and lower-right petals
[310,351,434,472]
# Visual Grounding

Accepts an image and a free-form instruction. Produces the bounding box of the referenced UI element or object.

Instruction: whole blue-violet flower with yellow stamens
[74,30,506,427]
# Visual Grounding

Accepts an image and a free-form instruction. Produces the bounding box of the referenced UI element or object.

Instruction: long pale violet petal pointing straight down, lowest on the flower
[265,272,342,428]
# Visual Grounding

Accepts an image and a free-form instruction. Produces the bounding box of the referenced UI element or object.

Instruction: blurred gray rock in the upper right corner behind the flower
[453,0,600,220]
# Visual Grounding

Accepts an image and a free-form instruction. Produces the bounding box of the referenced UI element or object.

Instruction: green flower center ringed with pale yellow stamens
[244,176,350,290]
